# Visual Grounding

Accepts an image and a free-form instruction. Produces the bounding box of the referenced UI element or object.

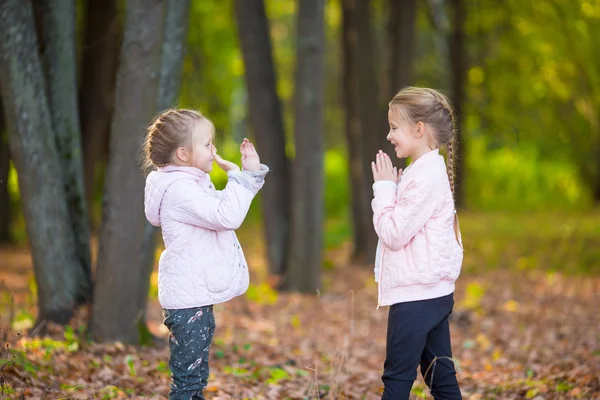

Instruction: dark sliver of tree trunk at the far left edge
[0,95,12,243]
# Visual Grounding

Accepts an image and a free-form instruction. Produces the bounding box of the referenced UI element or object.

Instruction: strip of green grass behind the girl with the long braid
[460,211,600,274]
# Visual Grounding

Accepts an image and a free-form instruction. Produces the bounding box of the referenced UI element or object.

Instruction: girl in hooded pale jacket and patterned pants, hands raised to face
[144,110,268,400]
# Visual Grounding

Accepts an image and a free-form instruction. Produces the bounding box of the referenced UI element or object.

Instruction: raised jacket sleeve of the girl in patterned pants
[169,166,268,231]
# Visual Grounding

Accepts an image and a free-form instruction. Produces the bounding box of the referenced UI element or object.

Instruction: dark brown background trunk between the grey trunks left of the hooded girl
[79,0,123,214]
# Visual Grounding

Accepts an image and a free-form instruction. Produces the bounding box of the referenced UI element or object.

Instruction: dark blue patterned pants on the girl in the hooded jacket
[163,306,215,400]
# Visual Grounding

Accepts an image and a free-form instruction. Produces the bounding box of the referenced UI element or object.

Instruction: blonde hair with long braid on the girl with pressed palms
[389,86,462,247]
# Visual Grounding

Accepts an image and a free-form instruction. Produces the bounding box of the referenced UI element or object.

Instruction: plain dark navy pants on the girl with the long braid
[382,294,462,400]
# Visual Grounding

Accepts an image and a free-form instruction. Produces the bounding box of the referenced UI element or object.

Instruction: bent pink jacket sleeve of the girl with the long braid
[371,180,436,251]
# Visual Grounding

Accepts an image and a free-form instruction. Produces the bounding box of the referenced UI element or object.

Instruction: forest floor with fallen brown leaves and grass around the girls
[0,212,600,400]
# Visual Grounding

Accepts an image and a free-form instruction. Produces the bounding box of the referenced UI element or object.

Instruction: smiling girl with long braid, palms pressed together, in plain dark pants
[372,87,463,400]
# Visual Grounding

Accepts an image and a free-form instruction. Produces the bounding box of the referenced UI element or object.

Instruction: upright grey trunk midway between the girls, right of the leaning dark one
[285,0,325,292]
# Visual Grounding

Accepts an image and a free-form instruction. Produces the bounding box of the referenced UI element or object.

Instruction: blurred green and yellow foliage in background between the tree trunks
[4,0,600,247]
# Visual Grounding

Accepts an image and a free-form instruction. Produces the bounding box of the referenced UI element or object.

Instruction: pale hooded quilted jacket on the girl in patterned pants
[144,165,268,309]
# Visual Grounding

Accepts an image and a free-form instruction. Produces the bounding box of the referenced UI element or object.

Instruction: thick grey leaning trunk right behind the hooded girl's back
[91,0,166,343]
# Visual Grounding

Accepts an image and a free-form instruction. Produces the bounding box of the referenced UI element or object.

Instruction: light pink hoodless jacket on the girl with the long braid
[372,150,463,307]
